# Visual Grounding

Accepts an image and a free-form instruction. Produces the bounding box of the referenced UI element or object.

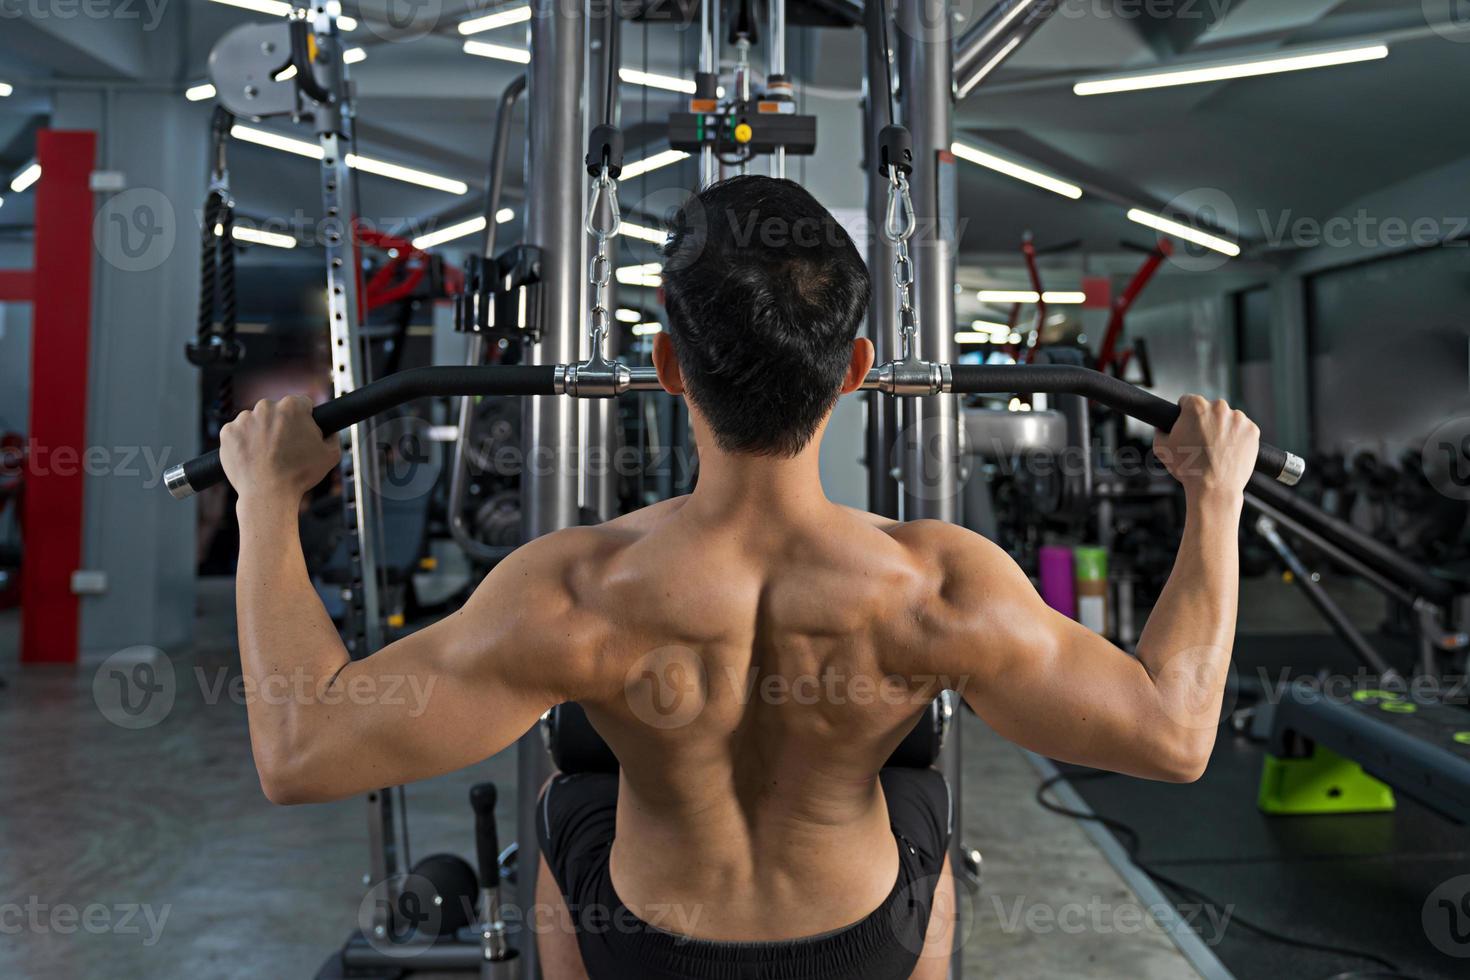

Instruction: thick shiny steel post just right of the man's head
[897,0,964,977]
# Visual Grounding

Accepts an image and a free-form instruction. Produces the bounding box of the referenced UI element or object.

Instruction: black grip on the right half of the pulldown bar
[950,364,1289,480]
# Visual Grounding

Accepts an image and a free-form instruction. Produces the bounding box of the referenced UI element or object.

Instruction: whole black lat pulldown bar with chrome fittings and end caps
[163,360,1305,500]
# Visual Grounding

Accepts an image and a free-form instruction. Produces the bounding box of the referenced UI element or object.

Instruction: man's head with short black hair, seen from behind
[663,176,872,455]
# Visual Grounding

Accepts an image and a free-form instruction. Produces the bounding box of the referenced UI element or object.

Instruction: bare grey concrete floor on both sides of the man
[0,582,1198,980]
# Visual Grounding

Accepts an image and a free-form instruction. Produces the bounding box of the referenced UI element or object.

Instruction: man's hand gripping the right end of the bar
[1154,395,1261,497]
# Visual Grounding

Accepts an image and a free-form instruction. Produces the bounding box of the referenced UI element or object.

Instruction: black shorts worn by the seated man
[537,768,951,980]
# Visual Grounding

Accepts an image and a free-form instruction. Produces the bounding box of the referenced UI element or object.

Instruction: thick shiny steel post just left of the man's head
[516,0,587,977]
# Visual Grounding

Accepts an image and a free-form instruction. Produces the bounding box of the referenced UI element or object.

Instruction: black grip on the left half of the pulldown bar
[170,364,556,494]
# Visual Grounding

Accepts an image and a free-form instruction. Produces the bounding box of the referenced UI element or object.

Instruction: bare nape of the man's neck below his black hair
[685,439,829,519]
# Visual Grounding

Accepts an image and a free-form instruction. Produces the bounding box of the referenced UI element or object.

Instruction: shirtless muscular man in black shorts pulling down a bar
[222,176,1258,980]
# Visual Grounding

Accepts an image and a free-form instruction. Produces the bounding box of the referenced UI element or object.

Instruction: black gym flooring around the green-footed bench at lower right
[1067,636,1470,980]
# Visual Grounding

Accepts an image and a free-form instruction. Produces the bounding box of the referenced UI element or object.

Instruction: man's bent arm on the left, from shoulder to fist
[221,400,588,804]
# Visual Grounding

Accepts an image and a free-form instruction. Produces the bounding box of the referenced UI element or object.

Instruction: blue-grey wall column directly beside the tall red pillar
[51,91,207,654]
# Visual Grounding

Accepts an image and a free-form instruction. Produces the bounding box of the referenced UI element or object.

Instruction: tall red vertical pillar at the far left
[21,129,97,664]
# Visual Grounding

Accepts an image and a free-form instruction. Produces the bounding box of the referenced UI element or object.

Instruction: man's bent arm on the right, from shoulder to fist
[923,397,1258,782]
